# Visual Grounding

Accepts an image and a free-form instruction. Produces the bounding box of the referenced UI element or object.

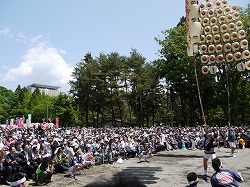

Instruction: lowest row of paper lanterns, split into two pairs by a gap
[201,60,250,74]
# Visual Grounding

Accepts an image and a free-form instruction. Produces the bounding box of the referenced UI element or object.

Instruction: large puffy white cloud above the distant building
[3,44,73,92]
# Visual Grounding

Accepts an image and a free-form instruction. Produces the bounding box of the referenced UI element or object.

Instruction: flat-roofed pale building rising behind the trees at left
[26,83,60,96]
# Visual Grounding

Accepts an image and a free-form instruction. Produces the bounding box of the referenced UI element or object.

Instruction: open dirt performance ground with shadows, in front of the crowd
[12,148,250,187]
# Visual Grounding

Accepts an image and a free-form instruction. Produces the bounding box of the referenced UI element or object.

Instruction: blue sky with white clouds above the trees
[0,0,249,92]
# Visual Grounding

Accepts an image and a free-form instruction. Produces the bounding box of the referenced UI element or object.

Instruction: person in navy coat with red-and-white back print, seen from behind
[211,158,244,187]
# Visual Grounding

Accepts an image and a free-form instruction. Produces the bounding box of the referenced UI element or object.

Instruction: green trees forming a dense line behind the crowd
[0,6,250,127]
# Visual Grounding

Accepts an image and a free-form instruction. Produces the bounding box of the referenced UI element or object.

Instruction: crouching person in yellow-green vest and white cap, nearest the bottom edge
[36,154,53,186]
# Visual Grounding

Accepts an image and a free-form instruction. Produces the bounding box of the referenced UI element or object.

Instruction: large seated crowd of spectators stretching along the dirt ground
[0,123,250,185]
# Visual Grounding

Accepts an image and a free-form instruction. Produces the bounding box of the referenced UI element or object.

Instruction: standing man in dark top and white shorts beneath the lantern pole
[201,125,217,176]
